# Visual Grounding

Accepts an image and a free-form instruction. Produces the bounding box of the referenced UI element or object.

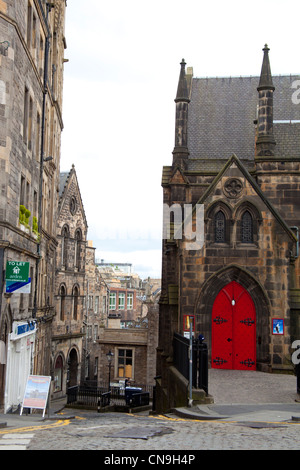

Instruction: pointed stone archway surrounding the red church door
[195,265,271,370]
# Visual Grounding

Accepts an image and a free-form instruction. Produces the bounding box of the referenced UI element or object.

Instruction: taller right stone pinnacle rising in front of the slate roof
[255,44,276,157]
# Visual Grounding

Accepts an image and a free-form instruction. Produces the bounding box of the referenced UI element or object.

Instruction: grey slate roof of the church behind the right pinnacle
[188,75,300,160]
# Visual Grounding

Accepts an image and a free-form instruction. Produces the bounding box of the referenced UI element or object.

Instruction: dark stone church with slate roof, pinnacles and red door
[157,45,300,409]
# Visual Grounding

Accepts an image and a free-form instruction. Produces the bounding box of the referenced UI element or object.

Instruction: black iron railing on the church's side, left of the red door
[173,333,208,394]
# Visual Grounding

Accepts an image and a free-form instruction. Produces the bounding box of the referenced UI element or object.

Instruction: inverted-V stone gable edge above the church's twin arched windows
[197,154,297,242]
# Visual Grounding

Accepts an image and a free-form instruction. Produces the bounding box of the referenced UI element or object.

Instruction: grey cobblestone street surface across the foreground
[24,413,300,452]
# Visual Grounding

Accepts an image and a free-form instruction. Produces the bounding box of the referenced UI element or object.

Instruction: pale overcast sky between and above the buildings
[61,0,300,278]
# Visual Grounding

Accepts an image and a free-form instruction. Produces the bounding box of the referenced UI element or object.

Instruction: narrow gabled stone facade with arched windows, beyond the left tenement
[51,165,87,399]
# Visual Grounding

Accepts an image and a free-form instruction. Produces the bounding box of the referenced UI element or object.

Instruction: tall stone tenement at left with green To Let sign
[0,0,66,411]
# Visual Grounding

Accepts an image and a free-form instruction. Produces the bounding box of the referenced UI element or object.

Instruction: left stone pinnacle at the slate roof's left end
[173,59,190,168]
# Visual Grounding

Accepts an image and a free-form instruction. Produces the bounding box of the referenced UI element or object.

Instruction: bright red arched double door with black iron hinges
[211,281,256,370]
